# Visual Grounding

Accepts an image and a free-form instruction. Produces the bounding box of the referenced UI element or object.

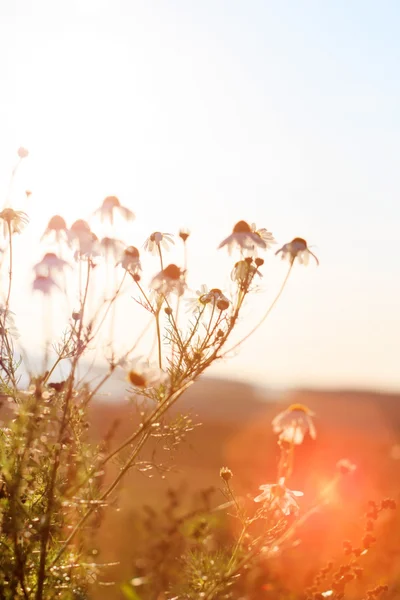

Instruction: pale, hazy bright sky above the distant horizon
[0,0,400,390]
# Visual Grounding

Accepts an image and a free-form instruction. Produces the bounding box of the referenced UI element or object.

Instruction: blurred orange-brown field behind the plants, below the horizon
[84,378,400,600]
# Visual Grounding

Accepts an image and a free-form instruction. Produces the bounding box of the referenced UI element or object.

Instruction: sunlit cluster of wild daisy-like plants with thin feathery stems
[0,148,396,600]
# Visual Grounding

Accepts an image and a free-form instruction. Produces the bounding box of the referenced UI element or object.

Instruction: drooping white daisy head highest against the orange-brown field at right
[272,404,317,445]
